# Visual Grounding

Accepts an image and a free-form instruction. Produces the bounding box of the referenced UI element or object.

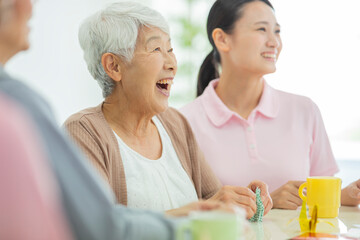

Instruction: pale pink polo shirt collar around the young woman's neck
[200,79,279,127]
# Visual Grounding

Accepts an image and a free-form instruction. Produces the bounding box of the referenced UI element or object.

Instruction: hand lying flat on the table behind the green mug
[165,200,234,217]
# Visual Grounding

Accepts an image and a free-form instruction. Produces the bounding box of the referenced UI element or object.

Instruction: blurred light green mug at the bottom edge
[176,211,245,240]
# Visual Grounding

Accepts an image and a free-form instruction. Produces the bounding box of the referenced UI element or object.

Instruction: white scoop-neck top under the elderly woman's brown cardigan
[115,117,198,211]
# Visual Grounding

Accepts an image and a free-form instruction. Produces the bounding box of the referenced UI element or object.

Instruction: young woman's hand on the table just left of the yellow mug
[270,181,304,209]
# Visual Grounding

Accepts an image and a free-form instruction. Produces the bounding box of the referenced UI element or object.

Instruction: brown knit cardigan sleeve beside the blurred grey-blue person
[64,104,127,205]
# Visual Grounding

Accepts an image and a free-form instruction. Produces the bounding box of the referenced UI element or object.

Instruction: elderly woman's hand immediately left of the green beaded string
[210,186,256,219]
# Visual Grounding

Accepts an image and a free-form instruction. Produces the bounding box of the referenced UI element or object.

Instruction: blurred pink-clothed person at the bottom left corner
[0,94,71,240]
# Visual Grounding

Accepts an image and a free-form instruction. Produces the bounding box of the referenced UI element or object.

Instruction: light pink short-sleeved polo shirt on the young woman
[180,79,338,192]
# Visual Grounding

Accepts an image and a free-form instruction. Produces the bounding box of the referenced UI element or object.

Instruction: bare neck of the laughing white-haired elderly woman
[102,88,155,138]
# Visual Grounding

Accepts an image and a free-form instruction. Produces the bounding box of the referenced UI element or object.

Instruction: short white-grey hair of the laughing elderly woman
[79,2,170,98]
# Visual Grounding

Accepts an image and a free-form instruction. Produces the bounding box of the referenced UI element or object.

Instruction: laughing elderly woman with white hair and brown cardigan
[65,2,272,218]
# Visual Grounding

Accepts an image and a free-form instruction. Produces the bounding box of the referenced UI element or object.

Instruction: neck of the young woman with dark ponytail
[215,62,264,119]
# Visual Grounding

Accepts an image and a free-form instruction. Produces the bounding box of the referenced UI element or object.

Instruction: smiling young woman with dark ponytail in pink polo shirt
[181,0,360,209]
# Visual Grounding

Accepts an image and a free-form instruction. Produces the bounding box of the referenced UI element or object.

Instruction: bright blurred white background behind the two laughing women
[7,0,360,182]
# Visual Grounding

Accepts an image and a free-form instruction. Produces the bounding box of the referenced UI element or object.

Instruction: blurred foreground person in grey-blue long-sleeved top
[0,0,229,240]
